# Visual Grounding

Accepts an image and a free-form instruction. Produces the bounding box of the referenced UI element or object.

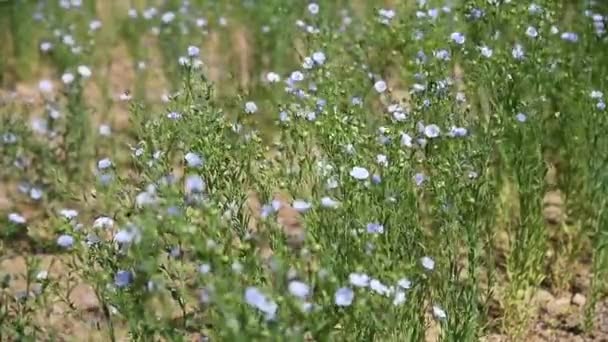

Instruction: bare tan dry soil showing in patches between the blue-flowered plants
[0,31,608,342]
